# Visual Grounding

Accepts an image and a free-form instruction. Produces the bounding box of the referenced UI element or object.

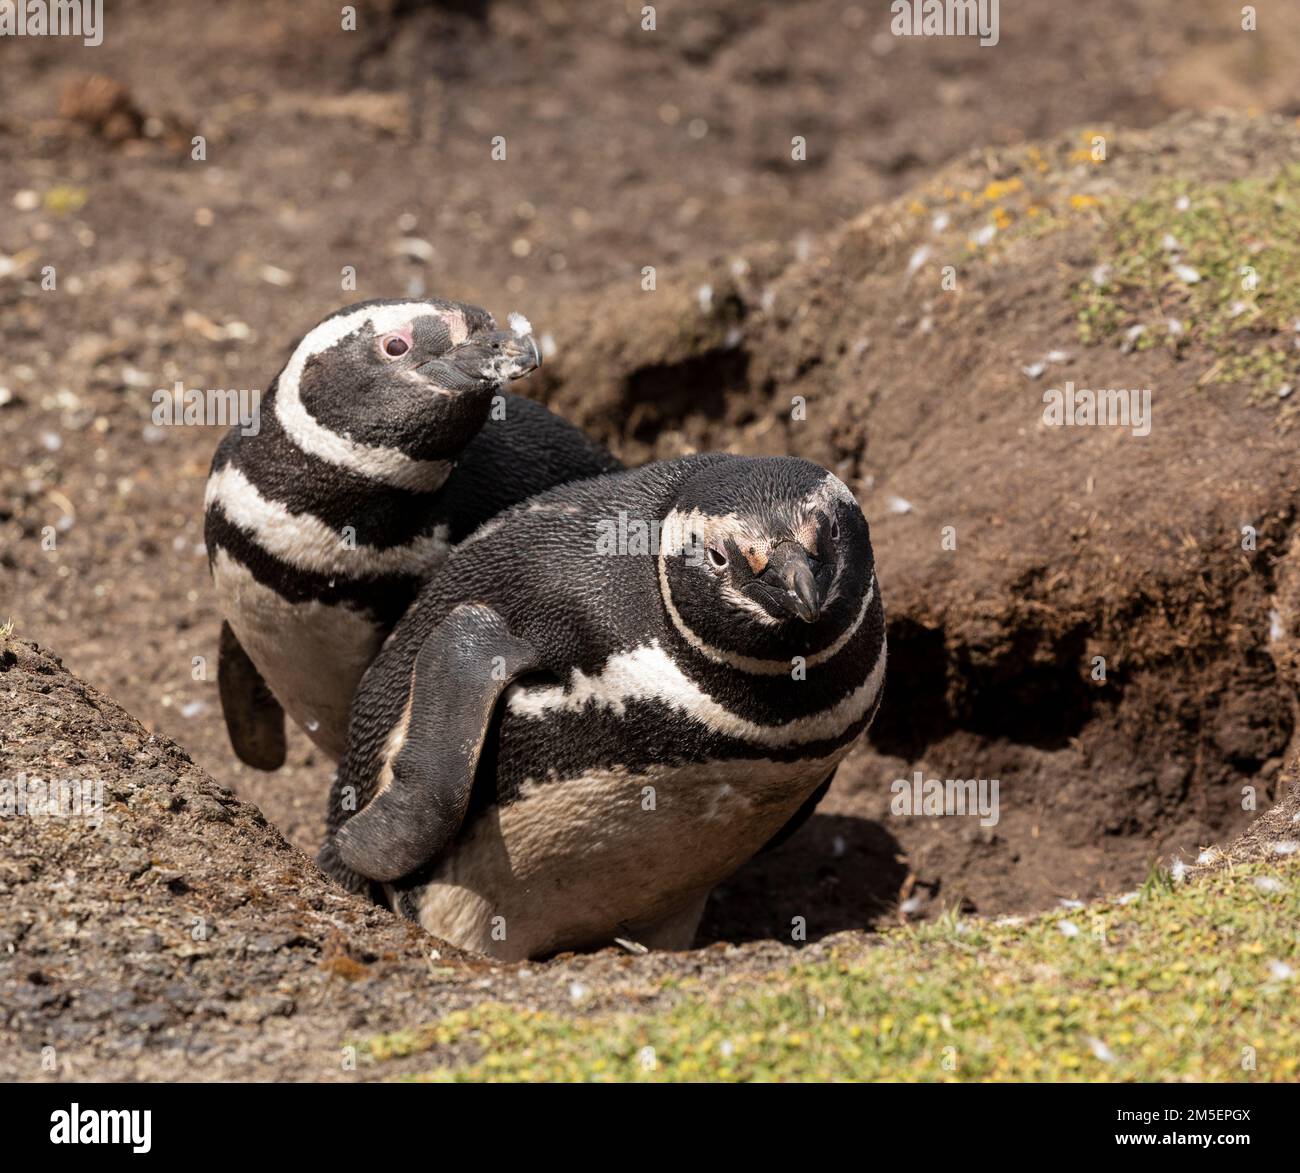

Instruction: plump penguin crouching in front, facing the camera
[322,455,885,960]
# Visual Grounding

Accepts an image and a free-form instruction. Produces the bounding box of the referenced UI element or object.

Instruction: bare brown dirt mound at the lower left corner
[0,640,428,1079]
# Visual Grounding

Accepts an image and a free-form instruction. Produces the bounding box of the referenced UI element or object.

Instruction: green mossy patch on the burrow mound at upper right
[1073,165,1300,402]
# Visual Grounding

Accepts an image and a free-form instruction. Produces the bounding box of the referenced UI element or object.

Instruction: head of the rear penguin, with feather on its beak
[276,299,541,471]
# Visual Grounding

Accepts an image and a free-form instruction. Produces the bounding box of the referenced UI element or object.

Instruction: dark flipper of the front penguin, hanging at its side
[335,603,540,880]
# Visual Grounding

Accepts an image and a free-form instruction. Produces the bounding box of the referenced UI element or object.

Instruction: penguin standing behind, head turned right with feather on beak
[204,300,620,770]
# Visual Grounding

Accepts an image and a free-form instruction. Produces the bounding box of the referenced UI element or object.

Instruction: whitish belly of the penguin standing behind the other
[212,550,384,761]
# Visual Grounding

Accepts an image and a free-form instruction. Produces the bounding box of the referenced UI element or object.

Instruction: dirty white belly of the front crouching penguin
[412,745,849,960]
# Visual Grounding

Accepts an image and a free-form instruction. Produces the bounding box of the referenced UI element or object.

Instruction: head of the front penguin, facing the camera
[659,456,875,661]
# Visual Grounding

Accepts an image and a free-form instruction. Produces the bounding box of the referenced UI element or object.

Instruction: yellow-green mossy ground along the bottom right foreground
[363,857,1300,1081]
